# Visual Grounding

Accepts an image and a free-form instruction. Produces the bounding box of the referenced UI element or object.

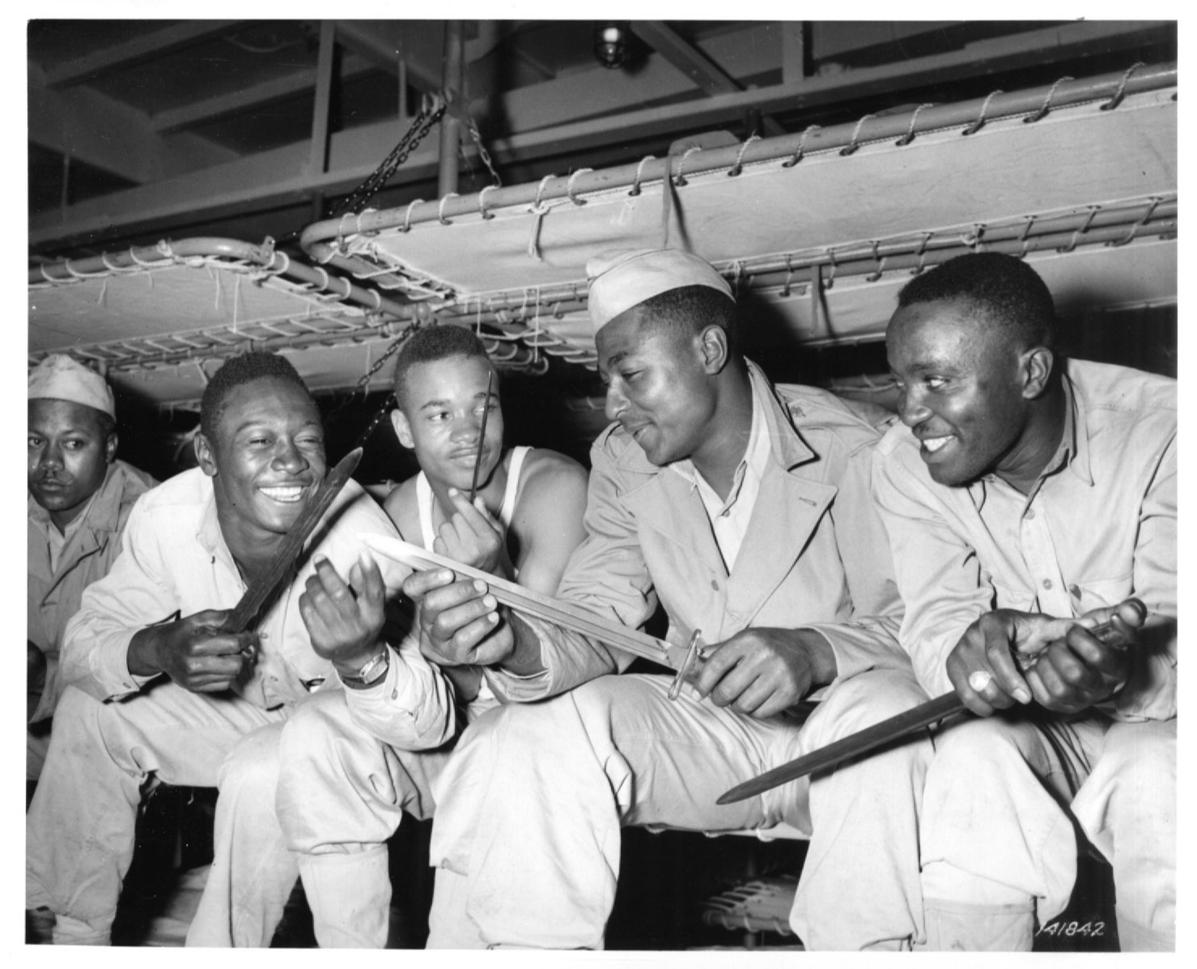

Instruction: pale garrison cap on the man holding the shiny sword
[587,249,734,330]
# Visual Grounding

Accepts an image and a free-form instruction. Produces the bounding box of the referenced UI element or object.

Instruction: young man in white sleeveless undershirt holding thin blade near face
[210,325,587,947]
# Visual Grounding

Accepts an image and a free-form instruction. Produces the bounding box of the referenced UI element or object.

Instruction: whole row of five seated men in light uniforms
[26,250,1177,950]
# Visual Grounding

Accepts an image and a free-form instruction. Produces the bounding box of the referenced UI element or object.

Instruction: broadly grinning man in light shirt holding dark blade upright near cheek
[25,353,423,944]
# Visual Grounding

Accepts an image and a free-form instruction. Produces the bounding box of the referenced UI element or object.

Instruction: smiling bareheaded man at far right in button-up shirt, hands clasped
[874,252,1177,950]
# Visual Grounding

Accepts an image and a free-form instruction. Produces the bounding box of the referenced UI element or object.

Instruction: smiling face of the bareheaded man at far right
[886,298,1059,492]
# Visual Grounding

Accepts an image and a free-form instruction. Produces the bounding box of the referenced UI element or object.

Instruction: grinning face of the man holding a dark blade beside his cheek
[196,376,327,561]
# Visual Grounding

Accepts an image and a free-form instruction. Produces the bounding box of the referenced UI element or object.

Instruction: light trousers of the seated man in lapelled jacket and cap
[429,671,930,949]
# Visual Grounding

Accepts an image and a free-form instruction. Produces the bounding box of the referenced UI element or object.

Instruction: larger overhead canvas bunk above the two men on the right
[302,63,1177,367]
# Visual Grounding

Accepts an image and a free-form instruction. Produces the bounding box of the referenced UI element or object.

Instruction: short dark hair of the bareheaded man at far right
[898,252,1056,347]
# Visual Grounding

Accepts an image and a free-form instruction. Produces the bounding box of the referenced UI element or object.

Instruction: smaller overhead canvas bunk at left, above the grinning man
[29,238,543,408]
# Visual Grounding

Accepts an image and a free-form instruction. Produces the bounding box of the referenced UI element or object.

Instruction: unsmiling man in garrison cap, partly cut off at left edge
[25,353,154,780]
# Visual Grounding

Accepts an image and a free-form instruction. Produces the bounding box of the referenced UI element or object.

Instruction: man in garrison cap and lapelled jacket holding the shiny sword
[405,249,925,949]
